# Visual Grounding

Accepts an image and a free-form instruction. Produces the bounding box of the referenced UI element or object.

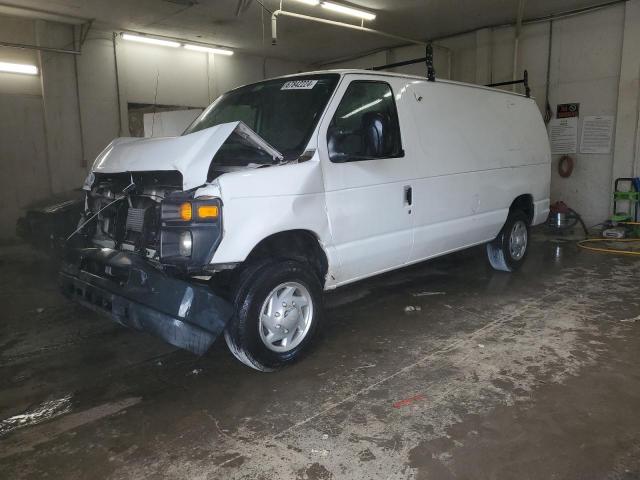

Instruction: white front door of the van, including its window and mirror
[318,76,413,284]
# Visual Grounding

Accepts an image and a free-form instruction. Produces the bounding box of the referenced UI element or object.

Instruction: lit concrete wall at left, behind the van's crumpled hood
[0,16,307,239]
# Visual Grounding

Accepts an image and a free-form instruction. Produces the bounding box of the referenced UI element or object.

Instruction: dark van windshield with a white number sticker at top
[183,74,339,161]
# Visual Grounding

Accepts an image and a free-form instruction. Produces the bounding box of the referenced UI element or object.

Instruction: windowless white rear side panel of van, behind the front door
[398,82,550,262]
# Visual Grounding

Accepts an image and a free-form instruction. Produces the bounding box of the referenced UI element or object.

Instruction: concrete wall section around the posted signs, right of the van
[549,5,624,224]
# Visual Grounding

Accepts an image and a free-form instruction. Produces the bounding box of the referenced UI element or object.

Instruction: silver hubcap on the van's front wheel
[258,282,313,352]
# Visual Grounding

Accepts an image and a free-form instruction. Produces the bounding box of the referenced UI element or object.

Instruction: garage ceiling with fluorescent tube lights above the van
[0,0,616,64]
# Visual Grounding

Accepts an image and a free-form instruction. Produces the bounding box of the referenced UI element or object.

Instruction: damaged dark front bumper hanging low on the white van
[60,248,233,355]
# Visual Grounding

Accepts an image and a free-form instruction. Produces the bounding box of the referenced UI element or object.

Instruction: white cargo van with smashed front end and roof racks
[61,70,550,370]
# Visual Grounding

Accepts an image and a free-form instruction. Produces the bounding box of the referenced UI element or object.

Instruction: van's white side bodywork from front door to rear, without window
[317,74,550,286]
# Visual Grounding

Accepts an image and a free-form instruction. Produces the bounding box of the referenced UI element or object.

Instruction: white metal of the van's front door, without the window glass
[318,74,414,284]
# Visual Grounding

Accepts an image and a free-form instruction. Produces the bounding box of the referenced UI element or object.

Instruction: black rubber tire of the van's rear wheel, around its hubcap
[487,210,530,272]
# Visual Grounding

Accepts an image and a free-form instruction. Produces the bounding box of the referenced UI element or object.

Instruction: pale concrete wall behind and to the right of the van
[326,0,640,224]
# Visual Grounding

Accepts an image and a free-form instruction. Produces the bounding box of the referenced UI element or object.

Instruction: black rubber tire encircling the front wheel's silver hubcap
[224,260,323,372]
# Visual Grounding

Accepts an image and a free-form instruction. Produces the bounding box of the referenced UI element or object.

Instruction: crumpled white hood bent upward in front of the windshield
[92,121,282,190]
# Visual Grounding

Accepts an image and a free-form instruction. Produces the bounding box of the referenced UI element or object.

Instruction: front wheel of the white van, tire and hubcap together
[225,261,322,371]
